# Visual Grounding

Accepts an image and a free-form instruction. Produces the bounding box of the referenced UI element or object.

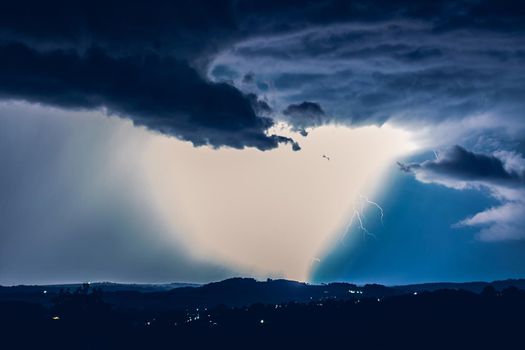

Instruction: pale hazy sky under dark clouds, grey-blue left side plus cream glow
[0,102,414,283]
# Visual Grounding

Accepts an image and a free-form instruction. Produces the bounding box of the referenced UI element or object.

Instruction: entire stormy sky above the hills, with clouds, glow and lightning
[0,0,525,285]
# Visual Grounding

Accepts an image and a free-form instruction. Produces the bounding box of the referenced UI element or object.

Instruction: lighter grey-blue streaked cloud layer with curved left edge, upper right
[210,16,525,142]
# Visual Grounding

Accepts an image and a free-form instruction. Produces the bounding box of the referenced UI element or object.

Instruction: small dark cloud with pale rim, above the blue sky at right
[399,146,525,187]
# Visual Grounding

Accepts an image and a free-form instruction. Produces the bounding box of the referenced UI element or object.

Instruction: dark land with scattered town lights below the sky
[0,279,525,349]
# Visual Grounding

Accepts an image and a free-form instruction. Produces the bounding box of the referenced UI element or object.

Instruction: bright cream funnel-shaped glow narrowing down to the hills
[139,125,415,280]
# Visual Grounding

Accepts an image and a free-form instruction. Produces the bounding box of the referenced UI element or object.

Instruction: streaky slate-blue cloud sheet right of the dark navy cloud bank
[227,27,525,125]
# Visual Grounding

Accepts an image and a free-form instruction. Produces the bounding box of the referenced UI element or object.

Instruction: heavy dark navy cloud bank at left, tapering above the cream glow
[0,44,292,150]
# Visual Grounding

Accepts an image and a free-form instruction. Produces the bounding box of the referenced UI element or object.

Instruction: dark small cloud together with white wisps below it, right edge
[399,146,525,241]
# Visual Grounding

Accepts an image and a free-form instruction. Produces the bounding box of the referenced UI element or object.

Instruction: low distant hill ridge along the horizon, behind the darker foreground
[0,277,525,309]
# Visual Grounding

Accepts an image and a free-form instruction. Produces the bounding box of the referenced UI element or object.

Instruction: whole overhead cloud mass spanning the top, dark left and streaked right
[0,0,525,149]
